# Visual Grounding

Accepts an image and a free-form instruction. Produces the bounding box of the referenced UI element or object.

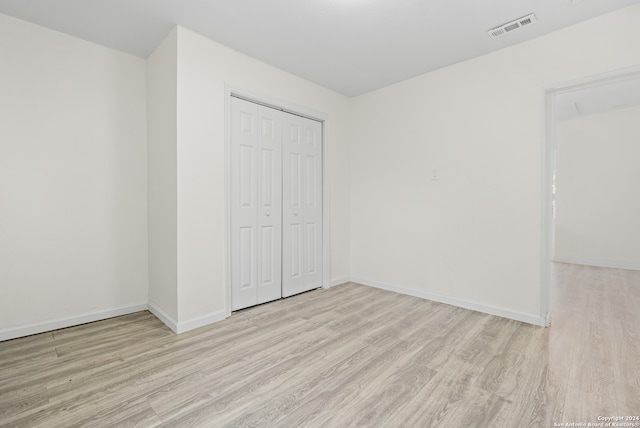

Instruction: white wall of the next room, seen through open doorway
[555,107,640,270]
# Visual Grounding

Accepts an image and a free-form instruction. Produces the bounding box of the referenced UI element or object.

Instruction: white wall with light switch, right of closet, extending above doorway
[351,6,640,323]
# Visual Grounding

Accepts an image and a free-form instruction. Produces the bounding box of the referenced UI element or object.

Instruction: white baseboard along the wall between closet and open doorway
[351,277,547,326]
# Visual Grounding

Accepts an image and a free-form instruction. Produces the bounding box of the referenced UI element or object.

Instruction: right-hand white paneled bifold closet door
[282,113,322,297]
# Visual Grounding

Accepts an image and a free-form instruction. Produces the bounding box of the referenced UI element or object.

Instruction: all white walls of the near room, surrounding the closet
[0,6,640,339]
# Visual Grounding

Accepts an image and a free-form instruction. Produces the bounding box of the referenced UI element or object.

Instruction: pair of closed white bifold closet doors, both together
[230,97,322,310]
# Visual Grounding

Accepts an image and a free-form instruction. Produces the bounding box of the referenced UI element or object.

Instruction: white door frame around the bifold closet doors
[224,84,331,317]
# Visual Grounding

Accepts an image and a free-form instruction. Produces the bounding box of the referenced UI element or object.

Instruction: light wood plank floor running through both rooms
[0,265,640,428]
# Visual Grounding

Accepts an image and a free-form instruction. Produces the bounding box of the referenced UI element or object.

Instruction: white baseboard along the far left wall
[0,303,147,341]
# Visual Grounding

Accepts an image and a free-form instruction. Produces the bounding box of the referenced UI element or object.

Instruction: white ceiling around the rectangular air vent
[0,0,640,96]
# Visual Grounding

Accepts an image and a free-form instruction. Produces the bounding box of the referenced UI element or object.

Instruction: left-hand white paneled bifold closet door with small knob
[231,97,282,310]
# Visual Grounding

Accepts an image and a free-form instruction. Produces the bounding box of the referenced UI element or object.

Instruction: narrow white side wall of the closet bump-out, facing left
[147,29,178,324]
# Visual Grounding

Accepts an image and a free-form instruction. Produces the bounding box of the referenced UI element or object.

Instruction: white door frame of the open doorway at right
[540,66,640,326]
